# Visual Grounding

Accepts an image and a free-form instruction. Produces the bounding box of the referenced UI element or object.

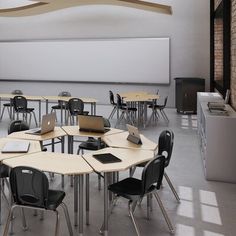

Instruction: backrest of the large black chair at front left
[10,166,49,209]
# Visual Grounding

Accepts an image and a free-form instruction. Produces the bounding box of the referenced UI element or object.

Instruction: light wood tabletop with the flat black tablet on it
[83,147,154,172]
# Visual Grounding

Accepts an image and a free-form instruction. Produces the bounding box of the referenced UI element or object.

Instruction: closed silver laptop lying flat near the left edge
[1,141,30,153]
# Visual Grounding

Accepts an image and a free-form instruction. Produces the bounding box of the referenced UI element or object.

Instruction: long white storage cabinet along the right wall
[197,92,236,183]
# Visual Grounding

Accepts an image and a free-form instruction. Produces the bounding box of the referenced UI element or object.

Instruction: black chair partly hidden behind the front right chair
[131,130,180,202]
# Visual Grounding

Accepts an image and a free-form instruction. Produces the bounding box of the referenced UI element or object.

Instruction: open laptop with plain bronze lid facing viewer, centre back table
[78,115,110,133]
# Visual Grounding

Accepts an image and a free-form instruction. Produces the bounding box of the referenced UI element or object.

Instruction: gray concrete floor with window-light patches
[0,105,236,236]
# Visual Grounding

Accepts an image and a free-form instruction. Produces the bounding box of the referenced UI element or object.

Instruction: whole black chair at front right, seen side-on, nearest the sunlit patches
[108,155,174,235]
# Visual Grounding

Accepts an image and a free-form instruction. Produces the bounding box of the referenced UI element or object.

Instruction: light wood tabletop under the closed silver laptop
[0,138,41,161]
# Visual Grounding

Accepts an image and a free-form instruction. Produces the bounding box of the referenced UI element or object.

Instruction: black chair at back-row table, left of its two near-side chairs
[13,95,38,126]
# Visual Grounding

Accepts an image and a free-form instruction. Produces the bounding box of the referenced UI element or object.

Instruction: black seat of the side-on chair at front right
[108,178,155,200]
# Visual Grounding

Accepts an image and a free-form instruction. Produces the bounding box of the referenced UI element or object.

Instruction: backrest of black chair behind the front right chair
[158,130,174,167]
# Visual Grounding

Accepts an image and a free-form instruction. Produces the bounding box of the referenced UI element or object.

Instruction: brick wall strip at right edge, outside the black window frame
[230,0,236,109]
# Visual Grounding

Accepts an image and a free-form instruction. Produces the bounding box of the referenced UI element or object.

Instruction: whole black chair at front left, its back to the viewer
[3,166,73,236]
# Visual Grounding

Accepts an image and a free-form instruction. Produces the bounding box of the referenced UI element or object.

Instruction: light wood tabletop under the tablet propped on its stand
[102,131,158,152]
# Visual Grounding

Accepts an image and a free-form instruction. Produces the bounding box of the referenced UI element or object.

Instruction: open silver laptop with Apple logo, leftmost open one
[25,112,56,135]
